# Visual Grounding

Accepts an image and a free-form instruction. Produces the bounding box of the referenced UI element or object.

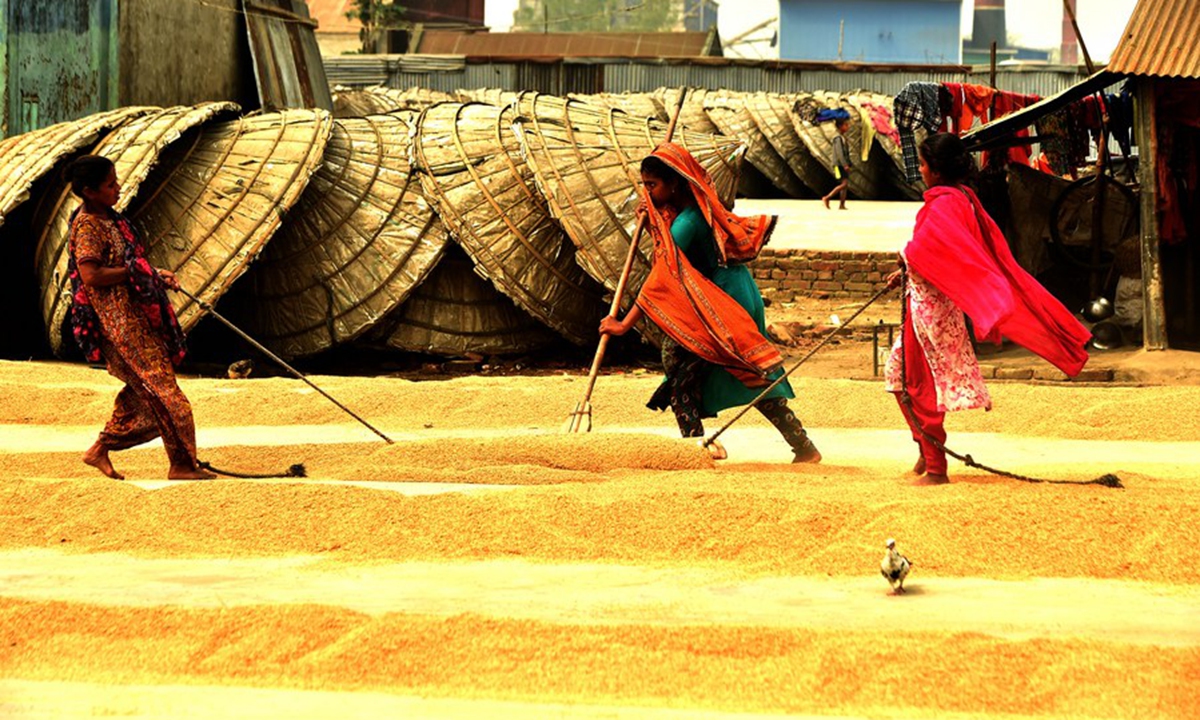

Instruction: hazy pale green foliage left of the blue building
[512,0,679,32]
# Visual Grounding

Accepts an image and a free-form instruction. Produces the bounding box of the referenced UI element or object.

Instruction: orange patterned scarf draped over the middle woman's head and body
[637,143,784,386]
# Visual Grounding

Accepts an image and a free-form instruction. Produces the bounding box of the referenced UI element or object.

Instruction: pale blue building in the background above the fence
[779,0,962,64]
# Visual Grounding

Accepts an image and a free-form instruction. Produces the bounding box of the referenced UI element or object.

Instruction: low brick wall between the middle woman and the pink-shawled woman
[750,248,896,302]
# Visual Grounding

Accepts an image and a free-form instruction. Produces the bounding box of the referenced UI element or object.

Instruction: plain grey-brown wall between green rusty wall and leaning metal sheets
[119,0,258,110]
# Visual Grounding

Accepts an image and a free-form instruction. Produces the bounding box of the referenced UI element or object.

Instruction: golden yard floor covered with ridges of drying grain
[0,362,1200,720]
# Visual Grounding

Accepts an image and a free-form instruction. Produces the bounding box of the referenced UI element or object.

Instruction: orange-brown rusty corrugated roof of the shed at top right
[1108,0,1200,78]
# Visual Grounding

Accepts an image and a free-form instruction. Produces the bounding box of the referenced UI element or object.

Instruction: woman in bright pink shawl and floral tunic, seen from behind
[887,133,1091,485]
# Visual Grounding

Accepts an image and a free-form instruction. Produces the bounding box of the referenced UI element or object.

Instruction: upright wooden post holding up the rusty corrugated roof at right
[1134,78,1168,350]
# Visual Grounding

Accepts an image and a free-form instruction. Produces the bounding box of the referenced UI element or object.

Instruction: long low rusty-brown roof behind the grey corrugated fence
[413,28,721,58]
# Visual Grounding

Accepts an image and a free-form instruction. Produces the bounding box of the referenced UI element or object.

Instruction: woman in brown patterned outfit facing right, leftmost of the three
[67,155,215,480]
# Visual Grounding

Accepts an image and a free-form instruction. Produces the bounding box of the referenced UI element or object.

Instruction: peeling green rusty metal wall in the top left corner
[0,0,118,136]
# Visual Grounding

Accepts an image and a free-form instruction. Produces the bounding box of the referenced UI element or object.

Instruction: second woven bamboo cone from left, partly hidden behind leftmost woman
[34,102,241,353]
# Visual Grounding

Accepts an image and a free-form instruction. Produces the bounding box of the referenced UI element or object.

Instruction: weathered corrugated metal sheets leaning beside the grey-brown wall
[242,0,334,110]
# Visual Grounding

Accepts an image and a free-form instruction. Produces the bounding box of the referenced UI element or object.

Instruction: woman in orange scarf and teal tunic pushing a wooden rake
[600,143,821,462]
